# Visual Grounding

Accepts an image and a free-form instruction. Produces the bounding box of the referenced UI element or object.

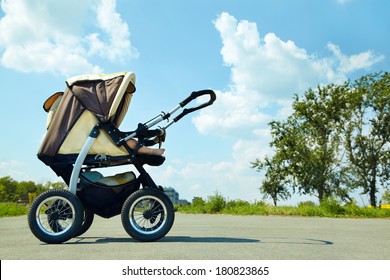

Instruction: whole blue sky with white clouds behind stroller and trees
[0,0,390,204]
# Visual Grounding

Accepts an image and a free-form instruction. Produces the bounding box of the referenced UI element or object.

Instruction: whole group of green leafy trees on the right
[252,73,390,206]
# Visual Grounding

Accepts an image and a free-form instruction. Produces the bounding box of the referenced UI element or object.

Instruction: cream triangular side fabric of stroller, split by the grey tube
[58,110,128,156]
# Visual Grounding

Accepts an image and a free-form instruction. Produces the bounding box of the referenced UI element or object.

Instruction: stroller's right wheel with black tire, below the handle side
[121,188,175,242]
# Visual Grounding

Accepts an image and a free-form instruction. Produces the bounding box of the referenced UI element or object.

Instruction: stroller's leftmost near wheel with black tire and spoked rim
[27,189,84,244]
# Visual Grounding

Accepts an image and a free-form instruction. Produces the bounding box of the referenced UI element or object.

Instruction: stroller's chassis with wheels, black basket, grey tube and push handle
[28,72,216,244]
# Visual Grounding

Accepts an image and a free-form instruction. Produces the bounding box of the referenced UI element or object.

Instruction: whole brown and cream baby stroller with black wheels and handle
[28,72,216,244]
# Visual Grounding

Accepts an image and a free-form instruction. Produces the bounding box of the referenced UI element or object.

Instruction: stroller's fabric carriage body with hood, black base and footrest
[38,72,165,183]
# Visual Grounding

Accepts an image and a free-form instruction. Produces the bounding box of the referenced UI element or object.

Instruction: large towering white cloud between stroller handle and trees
[186,13,384,200]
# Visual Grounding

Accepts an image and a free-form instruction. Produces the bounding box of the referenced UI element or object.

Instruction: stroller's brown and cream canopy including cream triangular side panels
[38,72,136,161]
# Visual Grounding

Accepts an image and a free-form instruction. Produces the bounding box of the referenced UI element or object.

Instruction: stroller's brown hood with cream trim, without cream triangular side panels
[38,72,135,160]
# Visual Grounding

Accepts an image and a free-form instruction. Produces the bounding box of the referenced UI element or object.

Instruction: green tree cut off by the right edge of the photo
[345,72,390,207]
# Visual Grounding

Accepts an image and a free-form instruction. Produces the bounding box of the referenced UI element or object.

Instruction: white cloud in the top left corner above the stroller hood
[0,0,138,75]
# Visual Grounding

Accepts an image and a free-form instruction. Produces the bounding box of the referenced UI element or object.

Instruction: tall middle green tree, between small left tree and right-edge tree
[288,82,350,202]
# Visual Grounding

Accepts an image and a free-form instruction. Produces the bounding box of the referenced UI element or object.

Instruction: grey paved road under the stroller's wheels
[0,213,390,260]
